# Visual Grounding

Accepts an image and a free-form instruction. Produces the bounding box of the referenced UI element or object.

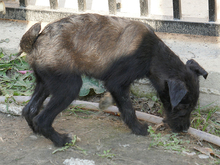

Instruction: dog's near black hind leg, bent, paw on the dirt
[33,75,82,147]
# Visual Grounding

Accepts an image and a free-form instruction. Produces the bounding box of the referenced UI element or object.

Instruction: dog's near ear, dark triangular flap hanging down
[167,80,187,109]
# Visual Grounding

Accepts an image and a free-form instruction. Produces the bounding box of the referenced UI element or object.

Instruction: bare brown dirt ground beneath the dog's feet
[0,104,217,165]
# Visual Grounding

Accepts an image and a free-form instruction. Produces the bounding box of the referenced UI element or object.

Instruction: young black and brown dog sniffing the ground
[20,14,208,147]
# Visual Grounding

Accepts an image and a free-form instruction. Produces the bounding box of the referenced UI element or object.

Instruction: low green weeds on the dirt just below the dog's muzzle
[148,126,190,152]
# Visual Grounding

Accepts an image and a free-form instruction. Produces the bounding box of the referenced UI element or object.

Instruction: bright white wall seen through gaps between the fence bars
[24,0,216,22]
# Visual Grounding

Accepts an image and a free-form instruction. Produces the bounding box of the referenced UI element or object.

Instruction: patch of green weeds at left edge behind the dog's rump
[0,52,35,97]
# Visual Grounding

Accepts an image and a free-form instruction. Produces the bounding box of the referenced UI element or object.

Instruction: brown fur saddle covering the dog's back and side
[24,14,149,76]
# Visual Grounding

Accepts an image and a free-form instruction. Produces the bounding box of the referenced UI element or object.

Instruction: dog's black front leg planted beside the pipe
[106,83,148,135]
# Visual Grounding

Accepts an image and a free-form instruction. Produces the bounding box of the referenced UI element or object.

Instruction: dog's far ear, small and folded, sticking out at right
[186,59,208,79]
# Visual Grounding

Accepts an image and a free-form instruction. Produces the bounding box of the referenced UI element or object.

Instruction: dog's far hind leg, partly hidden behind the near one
[22,73,49,131]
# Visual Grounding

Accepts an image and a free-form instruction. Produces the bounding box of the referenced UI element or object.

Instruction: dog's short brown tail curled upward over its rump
[17,23,41,55]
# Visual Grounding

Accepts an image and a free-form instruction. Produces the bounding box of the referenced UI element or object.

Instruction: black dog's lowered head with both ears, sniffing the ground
[164,60,208,132]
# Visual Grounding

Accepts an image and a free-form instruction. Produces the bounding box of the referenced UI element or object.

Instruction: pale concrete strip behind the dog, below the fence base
[0,19,220,106]
